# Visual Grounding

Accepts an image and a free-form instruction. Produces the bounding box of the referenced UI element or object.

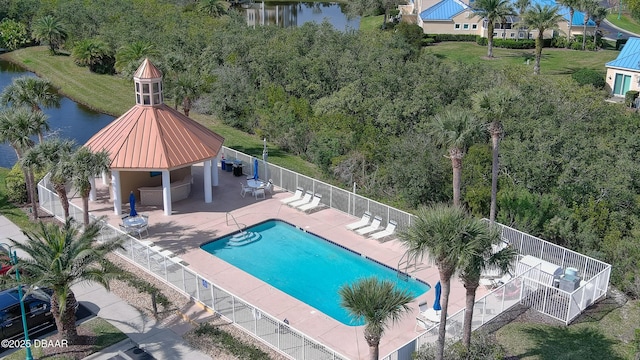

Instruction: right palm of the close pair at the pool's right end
[460,221,518,349]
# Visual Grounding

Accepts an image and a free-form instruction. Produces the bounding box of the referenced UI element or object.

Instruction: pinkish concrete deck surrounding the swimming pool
[71,164,486,359]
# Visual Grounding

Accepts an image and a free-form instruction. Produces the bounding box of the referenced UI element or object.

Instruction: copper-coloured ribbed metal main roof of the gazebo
[85,103,224,170]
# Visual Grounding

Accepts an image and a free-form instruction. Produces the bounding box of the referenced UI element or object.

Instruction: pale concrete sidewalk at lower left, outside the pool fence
[0,216,211,360]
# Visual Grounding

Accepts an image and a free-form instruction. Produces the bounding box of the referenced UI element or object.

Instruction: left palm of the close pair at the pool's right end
[398,204,477,360]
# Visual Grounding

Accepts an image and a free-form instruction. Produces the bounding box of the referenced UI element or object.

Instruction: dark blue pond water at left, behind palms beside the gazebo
[0,60,114,168]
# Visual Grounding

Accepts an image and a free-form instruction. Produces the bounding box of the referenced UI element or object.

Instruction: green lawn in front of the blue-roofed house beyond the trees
[425,42,619,75]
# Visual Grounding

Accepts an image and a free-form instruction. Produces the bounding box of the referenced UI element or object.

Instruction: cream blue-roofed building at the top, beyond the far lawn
[410,0,596,39]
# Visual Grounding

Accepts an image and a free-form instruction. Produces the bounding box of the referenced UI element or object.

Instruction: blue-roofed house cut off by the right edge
[605,37,640,97]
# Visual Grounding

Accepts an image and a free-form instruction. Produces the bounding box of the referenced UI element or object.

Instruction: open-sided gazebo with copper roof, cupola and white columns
[84,59,224,215]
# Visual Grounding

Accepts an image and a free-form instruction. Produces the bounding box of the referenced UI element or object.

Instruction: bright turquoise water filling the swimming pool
[200,220,429,326]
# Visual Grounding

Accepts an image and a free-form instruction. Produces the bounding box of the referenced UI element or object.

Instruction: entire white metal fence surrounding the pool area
[38,147,611,360]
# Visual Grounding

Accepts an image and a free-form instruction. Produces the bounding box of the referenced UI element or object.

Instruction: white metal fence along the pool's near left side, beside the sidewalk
[38,177,347,360]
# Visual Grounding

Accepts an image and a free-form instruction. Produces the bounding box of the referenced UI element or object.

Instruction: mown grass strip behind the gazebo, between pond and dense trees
[1,46,321,178]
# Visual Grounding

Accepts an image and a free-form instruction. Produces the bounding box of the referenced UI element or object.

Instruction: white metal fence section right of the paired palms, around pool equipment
[382,224,611,360]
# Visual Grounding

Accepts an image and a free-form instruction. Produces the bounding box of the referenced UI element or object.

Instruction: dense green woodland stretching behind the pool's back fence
[0,0,640,295]
